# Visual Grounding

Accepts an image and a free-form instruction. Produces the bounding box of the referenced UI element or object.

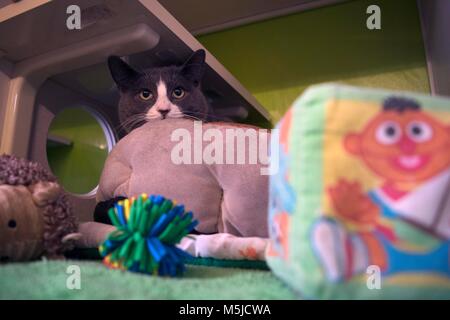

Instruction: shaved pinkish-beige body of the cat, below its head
[97,119,270,237]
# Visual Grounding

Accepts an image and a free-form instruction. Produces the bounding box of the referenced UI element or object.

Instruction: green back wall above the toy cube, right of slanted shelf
[198,0,430,122]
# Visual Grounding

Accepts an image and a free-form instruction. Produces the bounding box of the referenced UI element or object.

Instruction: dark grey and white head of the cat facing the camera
[108,50,213,132]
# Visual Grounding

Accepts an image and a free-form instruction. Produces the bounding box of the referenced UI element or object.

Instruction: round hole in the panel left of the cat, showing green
[47,107,115,195]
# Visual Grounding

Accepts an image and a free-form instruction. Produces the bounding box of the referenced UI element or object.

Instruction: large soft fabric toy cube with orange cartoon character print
[266,85,450,299]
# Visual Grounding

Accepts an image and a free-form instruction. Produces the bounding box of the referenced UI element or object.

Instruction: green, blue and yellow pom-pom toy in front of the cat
[99,194,198,277]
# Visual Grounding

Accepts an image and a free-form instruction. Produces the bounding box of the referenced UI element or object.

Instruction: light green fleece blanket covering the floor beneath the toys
[0,260,297,300]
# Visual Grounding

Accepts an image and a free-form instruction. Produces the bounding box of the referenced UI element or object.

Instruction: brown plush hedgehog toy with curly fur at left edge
[0,155,79,262]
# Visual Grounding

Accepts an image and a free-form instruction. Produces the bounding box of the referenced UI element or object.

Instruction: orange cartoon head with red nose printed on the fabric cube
[344,98,450,189]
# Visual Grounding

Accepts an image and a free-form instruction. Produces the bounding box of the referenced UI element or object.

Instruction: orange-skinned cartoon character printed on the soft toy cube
[312,97,450,281]
